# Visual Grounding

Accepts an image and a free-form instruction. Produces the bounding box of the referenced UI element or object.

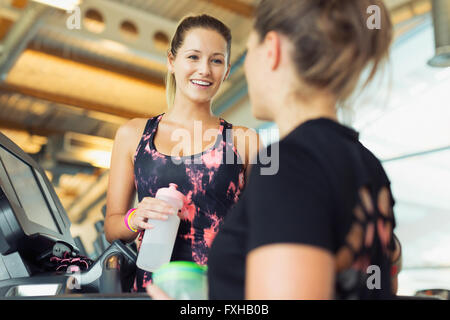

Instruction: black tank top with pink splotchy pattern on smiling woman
[134,114,245,291]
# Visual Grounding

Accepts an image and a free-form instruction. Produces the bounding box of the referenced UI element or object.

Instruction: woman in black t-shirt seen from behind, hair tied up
[148,0,400,300]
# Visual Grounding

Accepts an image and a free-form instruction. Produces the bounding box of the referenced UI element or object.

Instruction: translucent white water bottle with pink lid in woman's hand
[136,183,184,272]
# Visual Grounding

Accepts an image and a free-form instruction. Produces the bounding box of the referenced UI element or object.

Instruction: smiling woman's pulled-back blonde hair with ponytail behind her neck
[166,14,232,108]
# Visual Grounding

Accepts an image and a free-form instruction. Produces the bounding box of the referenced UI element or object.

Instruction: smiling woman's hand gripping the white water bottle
[130,197,178,231]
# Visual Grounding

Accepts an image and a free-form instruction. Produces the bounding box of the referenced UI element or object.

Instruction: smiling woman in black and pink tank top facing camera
[105,15,259,291]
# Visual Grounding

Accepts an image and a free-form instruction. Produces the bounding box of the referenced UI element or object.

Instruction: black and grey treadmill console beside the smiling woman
[0,133,148,299]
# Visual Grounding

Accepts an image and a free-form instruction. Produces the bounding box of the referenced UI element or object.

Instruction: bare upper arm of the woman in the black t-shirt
[245,243,335,300]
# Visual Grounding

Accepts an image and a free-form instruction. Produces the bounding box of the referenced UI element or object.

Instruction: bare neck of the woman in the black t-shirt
[274,92,338,139]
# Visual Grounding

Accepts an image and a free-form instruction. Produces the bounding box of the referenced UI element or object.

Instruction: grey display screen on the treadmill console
[0,146,60,233]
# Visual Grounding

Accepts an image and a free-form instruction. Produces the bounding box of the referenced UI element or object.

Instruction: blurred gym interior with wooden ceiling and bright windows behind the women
[0,0,450,295]
